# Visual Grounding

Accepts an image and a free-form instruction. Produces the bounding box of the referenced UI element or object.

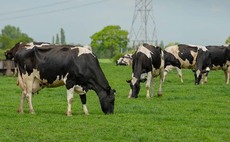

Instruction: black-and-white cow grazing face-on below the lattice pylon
[127,44,164,98]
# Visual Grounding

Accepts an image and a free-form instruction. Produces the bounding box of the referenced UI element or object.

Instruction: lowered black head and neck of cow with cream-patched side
[193,48,211,85]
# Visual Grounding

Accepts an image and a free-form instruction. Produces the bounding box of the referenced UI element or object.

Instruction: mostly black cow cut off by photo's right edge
[205,45,230,84]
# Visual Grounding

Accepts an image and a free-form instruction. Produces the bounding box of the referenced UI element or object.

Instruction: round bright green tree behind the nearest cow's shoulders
[90,25,129,58]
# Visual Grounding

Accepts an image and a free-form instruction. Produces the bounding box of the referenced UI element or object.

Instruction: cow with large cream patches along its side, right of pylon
[163,44,210,84]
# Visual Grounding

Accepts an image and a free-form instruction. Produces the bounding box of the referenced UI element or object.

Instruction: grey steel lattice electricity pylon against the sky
[129,0,157,46]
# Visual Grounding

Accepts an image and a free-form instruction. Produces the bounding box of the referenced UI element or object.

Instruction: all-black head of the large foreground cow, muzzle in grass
[100,87,116,114]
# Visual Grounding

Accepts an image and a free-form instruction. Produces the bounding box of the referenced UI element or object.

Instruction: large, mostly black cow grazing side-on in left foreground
[15,45,115,116]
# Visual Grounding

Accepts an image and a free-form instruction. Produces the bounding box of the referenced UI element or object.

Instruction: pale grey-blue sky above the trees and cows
[0,0,230,45]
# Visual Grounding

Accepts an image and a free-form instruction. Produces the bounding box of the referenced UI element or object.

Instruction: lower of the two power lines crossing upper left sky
[0,0,108,21]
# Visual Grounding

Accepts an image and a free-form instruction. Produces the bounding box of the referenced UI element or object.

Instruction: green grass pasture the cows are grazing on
[0,60,230,142]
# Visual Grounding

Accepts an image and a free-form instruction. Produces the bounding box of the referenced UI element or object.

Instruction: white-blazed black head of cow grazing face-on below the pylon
[126,77,141,98]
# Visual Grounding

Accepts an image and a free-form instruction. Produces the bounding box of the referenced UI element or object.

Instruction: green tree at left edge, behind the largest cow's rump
[0,25,33,49]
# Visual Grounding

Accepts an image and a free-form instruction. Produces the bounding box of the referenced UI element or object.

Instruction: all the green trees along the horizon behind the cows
[0,25,230,58]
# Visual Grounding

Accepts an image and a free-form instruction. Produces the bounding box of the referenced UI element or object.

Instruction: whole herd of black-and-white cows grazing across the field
[5,42,230,116]
